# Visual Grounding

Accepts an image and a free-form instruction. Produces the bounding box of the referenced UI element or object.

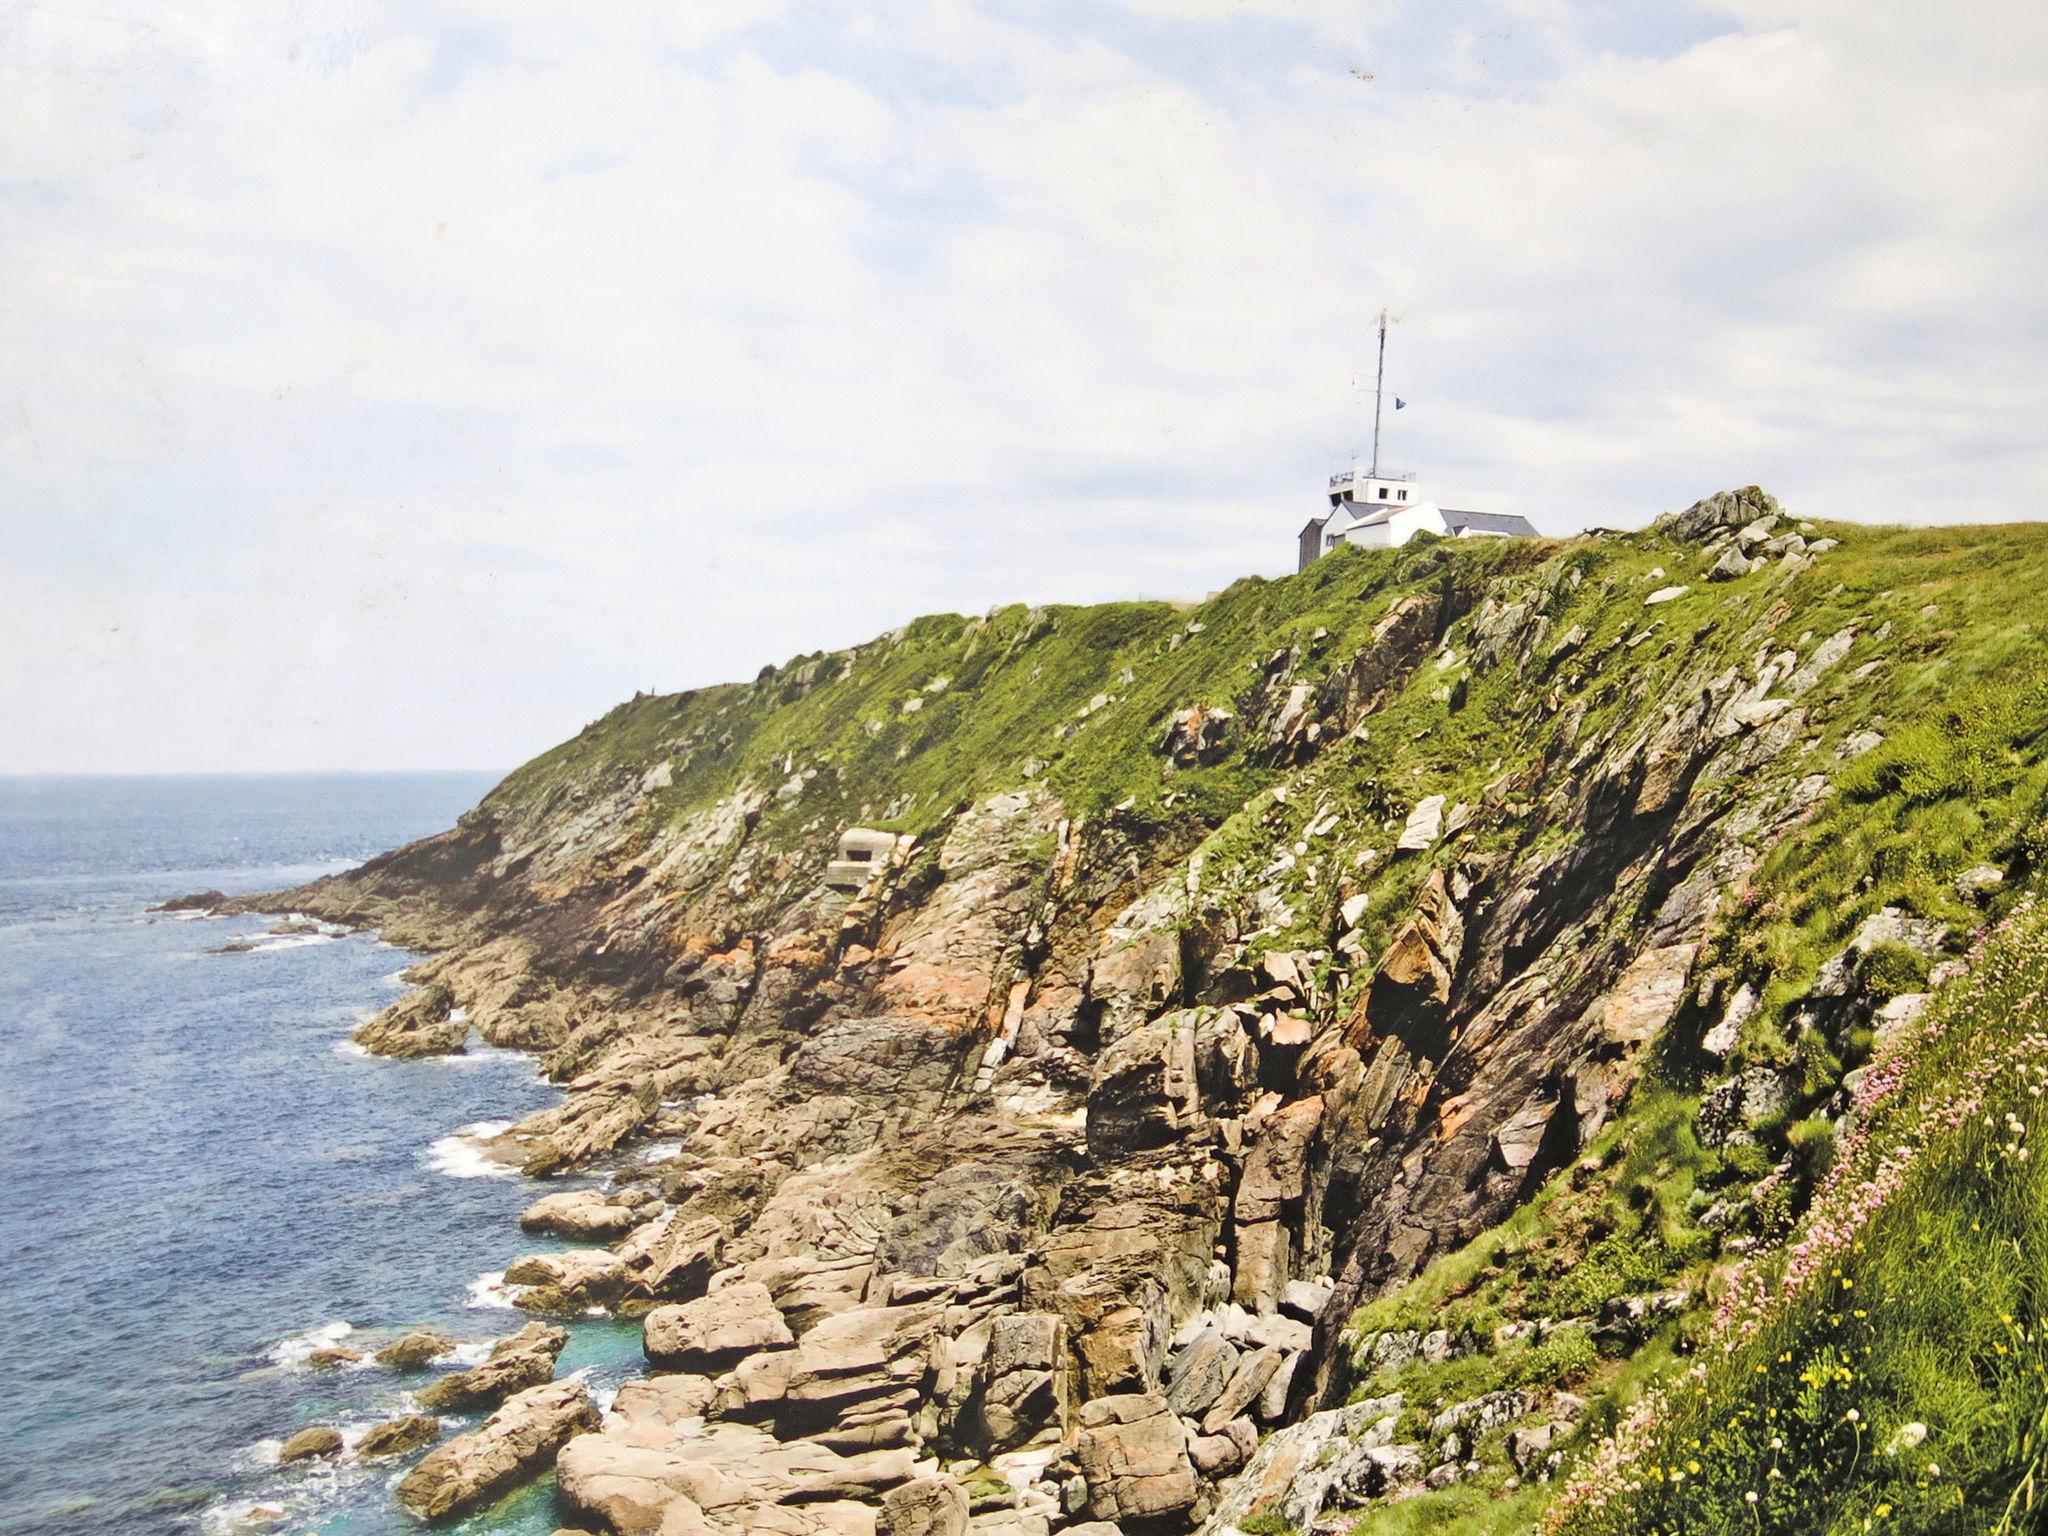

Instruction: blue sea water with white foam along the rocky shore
[0,774,639,1536]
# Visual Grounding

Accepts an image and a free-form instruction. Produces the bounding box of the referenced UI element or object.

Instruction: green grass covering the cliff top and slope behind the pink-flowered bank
[452,514,2048,1532]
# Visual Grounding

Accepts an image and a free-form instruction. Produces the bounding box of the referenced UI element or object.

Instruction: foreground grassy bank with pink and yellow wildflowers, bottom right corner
[1552,907,2048,1536]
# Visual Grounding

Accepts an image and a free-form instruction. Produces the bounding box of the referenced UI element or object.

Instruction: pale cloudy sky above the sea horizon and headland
[0,0,2048,772]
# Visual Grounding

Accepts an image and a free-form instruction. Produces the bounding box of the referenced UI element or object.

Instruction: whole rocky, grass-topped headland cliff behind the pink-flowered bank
[247,489,2048,1536]
